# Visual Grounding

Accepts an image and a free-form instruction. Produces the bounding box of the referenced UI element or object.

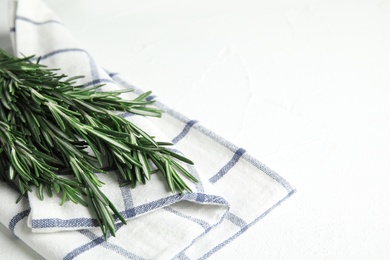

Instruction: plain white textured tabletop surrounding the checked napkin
[0,0,390,259]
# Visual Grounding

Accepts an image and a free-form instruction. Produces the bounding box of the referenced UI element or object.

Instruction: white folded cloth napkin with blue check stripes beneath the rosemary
[0,0,294,259]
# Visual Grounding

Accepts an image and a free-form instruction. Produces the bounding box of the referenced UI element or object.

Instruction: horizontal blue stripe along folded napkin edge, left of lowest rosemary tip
[31,218,99,228]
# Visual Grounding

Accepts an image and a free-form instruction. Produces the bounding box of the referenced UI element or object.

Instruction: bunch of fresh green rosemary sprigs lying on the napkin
[0,49,197,237]
